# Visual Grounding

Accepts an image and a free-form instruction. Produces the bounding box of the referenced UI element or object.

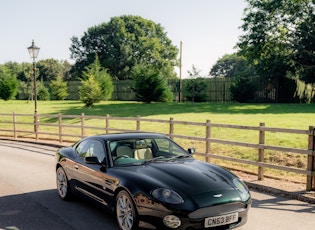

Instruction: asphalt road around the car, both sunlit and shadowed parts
[0,140,315,230]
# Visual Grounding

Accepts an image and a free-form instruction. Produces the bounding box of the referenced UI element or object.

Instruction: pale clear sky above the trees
[0,0,246,78]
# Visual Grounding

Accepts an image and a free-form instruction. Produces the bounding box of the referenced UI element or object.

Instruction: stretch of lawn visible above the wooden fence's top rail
[0,100,315,129]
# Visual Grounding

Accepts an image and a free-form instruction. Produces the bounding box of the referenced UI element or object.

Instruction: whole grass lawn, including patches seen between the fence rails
[0,100,315,181]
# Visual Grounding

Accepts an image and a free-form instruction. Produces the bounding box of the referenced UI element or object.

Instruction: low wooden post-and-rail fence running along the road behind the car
[0,113,315,191]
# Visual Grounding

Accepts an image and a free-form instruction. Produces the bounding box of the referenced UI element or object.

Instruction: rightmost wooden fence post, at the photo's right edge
[306,126,315,191]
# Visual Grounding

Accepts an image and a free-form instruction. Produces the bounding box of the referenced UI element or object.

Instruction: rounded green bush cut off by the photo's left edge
[0,67,18,101]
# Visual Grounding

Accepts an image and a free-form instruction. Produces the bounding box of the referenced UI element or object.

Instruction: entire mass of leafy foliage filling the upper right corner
[238,0,315,90]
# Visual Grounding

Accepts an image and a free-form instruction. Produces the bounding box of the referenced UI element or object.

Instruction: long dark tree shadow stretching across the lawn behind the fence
[53,102,315,117]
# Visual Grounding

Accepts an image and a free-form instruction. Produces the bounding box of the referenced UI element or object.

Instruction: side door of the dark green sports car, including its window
[75,139,113,205]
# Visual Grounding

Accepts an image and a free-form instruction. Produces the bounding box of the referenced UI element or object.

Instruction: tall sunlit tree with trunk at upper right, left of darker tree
[238,0,314,102]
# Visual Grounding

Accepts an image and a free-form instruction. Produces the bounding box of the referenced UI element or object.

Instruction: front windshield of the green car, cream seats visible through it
[109,138,190,165]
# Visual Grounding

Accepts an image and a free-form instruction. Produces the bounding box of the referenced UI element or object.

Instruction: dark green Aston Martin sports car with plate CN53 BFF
[56,132,251,230]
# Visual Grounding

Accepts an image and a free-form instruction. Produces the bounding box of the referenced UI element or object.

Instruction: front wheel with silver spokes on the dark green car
[115,190,138,230]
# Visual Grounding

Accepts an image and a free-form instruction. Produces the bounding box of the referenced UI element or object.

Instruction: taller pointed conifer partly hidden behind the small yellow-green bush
[83,55,114,100]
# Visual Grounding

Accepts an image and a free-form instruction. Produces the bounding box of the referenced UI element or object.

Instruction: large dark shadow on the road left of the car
[0,189,118,230]
